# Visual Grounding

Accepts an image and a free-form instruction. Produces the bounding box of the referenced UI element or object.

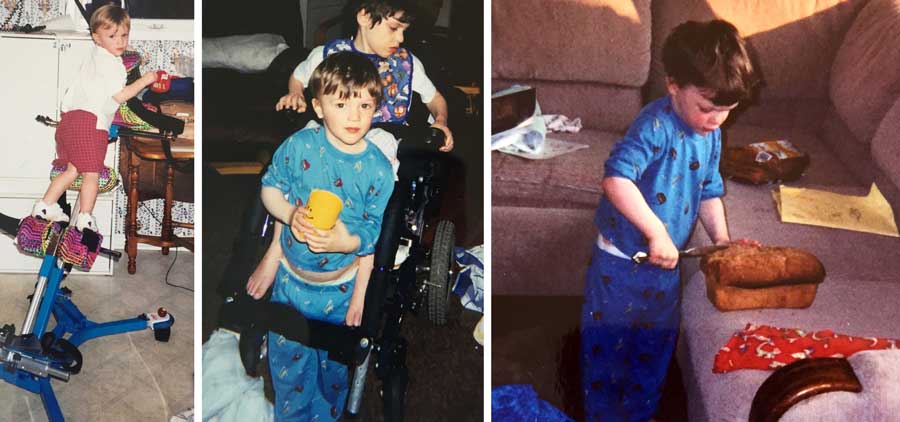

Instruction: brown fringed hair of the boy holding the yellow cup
[309,51,381,105]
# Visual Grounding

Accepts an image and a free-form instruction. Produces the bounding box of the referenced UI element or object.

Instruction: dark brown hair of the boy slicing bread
[663,20,759,106]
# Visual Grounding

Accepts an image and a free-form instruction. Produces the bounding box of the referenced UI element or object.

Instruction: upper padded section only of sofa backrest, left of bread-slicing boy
[491,0,650,87]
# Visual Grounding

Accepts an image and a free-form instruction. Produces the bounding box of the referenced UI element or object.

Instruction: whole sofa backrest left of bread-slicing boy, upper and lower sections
[491,0,650,130]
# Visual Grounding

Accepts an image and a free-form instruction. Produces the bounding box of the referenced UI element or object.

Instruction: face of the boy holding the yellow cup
[312,89,376,153]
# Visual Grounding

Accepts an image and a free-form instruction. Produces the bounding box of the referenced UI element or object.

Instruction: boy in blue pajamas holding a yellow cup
[255,53,394,421]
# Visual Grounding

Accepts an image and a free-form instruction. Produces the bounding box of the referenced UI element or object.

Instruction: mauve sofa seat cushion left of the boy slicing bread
[491,130,622,209]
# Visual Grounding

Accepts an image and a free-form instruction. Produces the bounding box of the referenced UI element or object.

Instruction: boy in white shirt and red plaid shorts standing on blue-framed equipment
[31,4,156,232]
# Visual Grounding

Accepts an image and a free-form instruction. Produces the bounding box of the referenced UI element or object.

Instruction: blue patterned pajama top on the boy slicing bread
[594,96,724,256]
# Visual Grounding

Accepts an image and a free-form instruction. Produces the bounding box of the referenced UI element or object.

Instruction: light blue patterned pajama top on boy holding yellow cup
[262,127,394,272]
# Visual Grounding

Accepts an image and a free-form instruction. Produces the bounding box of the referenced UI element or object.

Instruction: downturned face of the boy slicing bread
[666,78,738,136]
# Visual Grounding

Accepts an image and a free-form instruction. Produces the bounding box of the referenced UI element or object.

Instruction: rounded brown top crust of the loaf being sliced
[700,245,825,289]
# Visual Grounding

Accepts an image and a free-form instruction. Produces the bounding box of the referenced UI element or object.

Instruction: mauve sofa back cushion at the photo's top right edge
[830,0,900,142]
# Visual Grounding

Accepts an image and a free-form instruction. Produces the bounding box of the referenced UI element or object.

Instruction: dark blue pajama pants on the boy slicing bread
[581,245,680,422]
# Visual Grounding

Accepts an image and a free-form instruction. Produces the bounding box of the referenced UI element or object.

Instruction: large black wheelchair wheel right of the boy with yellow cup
[427,220,456,325]
